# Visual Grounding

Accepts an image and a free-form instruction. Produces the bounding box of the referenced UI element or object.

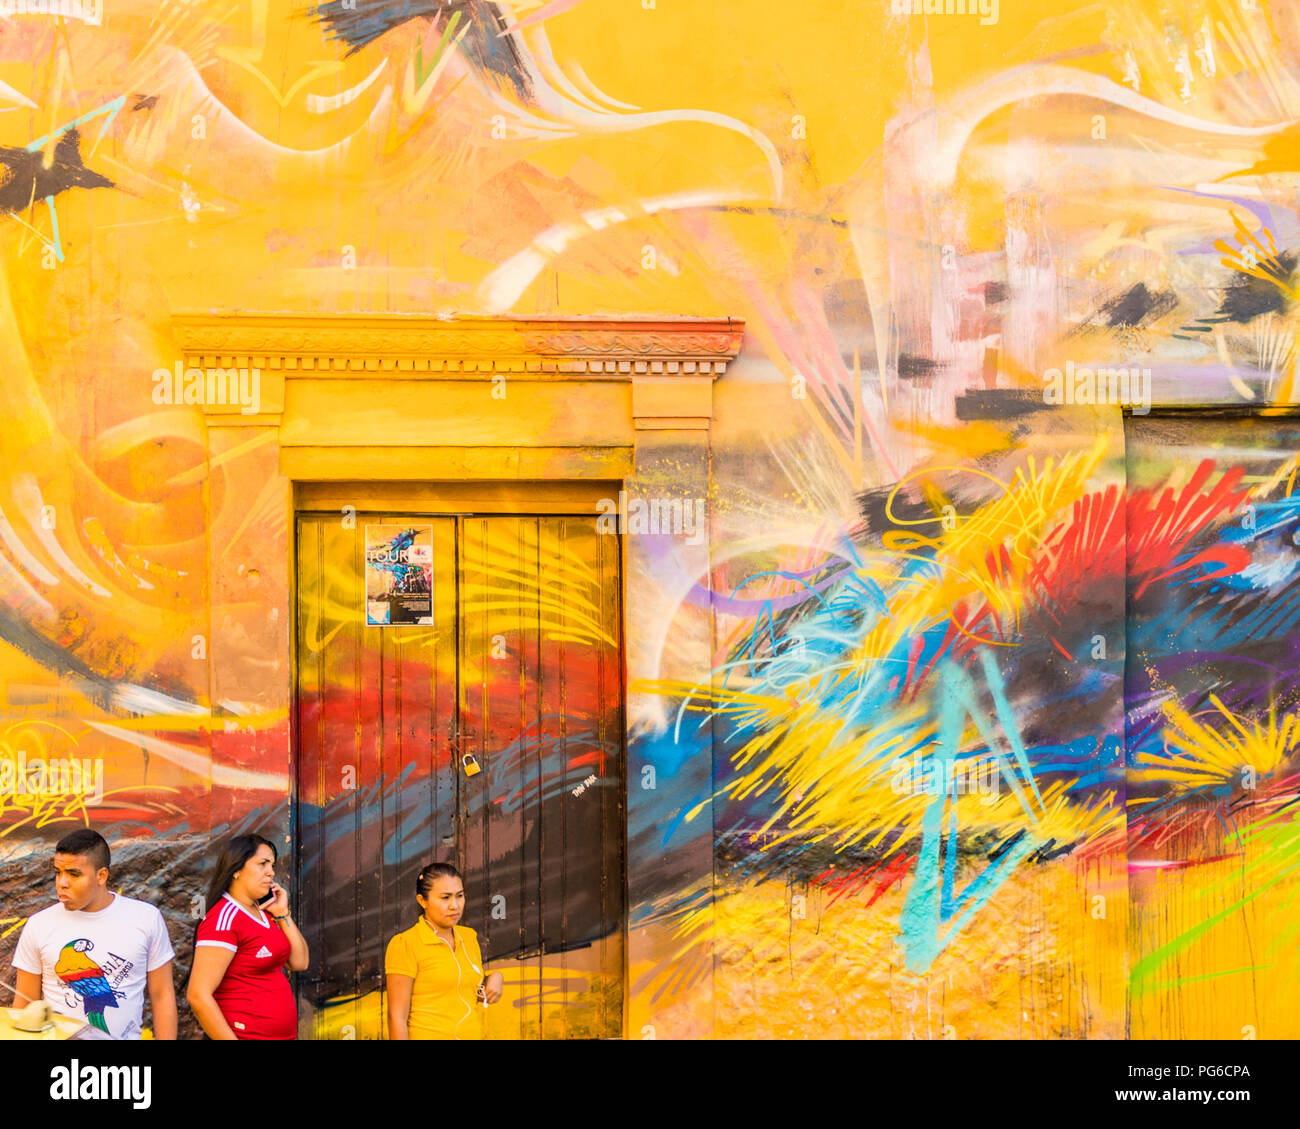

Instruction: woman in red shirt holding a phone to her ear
[185,835,308,1039]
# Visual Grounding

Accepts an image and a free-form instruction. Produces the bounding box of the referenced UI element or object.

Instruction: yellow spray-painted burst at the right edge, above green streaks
[1138,695,1300,790]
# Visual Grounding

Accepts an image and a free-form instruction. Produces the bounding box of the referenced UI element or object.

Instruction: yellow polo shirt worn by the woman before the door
[384,917,484,1039]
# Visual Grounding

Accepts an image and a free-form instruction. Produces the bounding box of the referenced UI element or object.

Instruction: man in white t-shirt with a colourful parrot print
[13,827,176,1039]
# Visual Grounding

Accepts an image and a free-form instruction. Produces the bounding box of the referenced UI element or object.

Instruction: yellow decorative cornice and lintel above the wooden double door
[169,312,745,481]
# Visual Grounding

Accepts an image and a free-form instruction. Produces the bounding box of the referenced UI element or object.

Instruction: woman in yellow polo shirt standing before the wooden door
[384,862,502,1039]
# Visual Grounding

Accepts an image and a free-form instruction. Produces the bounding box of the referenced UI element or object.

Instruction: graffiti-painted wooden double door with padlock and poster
[294,505,627,1038]
